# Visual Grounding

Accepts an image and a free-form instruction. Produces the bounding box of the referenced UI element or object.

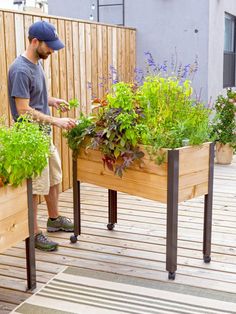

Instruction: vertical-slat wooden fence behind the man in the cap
[0,10,136,191]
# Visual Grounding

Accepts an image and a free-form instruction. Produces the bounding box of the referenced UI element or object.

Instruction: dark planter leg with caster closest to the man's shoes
[70,160,81,243]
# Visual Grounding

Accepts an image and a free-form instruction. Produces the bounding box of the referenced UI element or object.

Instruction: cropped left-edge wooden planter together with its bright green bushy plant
[0,117,49,289]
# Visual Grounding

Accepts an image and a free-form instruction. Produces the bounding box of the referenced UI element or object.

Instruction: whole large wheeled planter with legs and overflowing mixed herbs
[65,75,213,279]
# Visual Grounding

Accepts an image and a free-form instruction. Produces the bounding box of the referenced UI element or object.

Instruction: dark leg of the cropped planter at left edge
[25,179,36,290]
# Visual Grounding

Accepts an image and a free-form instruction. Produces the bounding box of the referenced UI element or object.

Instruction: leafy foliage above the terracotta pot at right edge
[213,89,236,152]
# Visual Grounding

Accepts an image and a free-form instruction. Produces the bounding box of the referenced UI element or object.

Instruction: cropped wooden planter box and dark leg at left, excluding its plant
[0,180,36,289]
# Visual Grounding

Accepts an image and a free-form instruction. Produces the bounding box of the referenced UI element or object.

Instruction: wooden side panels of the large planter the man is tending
[77,143,210,203]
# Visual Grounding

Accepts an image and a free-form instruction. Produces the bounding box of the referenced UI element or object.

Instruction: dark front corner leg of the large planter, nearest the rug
[166,150,179,280]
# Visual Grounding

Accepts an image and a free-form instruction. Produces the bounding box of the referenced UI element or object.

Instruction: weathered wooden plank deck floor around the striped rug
[0,159,236,314]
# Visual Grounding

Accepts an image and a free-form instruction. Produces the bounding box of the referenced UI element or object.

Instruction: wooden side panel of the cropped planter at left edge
[0,181,29,253]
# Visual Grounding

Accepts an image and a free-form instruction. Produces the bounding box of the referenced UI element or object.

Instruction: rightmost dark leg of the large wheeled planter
[203,143,214,263]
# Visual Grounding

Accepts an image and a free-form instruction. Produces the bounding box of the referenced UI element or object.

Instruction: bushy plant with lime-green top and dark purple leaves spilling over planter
[91,82,144,176]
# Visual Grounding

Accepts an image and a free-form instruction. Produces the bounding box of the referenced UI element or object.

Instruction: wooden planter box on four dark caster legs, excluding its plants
[71,143,214,279]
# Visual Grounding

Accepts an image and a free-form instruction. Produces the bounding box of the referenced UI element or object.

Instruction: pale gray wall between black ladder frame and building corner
[125,0,209,100]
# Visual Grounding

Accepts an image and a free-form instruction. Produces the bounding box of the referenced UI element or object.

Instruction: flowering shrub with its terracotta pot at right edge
[213,89,236,164]
